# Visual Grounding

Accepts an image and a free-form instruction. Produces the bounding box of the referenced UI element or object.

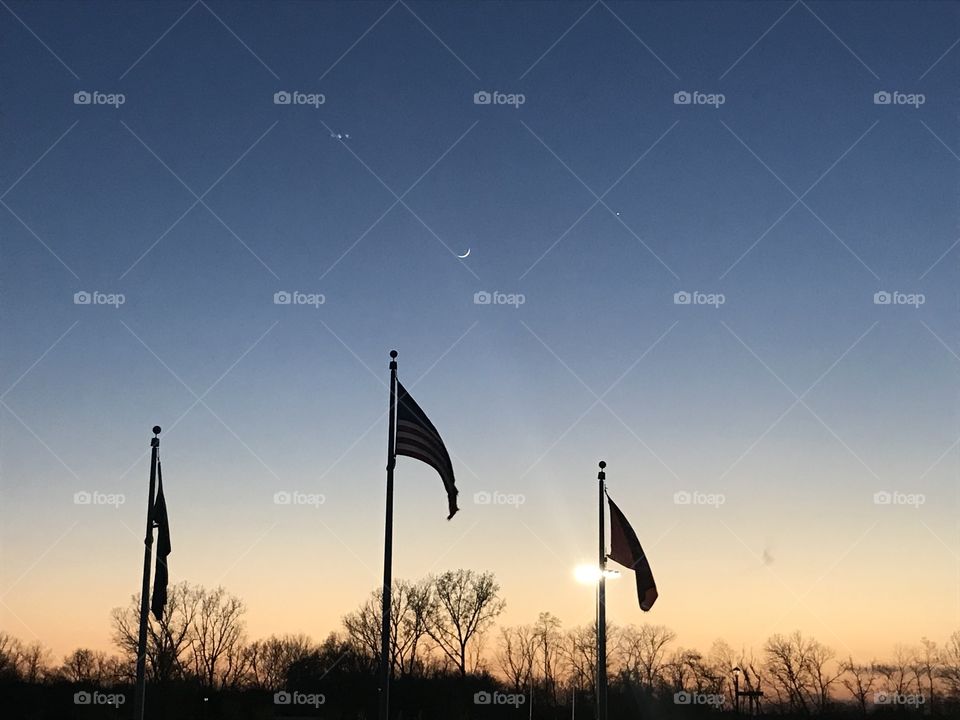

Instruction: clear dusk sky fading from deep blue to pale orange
[0,0,960,658]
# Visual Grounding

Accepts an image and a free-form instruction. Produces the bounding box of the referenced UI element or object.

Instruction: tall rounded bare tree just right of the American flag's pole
[427,569,506,677]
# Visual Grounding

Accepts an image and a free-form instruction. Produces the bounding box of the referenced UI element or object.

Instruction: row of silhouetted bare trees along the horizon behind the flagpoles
[0,569,960,719]
